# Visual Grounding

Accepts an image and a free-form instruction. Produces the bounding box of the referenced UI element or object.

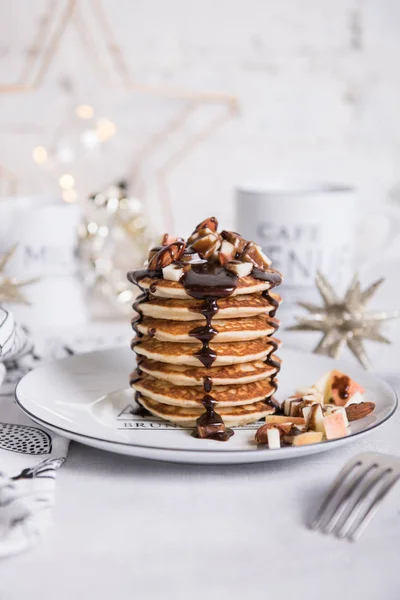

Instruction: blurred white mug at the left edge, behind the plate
[0,196,86,329]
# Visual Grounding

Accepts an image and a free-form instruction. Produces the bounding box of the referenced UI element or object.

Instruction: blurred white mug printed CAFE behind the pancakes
[236,183,356,303]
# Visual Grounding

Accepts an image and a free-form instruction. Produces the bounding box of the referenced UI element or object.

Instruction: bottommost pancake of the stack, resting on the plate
[138,396,275,427]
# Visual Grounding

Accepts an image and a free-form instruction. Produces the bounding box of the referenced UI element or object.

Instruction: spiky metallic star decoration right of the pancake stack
[288,273,400,369]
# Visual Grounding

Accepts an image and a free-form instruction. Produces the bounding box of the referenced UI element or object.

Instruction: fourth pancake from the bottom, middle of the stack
[134,337,278,370]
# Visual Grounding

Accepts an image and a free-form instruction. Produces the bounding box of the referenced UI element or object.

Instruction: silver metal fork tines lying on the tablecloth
[310,452,400,541]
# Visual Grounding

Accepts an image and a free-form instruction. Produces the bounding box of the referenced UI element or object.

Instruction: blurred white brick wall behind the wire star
[0,0,400,231]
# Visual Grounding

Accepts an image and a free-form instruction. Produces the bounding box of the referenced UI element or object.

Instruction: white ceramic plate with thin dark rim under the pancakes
[16,348,397,464]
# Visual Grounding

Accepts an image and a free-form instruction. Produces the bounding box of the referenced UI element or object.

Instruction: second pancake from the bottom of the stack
[132,375,276,412]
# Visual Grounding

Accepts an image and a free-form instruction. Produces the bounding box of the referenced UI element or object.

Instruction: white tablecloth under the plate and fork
[0,324,400,600]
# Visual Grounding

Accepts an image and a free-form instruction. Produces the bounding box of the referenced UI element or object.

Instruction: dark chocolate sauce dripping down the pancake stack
[128,262,282,441]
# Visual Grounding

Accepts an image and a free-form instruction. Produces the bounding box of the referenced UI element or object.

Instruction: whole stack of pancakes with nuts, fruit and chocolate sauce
[128,217,281,439]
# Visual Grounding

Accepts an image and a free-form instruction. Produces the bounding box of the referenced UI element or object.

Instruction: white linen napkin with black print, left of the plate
[0,307,69,557]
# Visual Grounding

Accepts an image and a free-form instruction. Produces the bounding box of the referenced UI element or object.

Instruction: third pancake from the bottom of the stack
[136,354,279,386]
